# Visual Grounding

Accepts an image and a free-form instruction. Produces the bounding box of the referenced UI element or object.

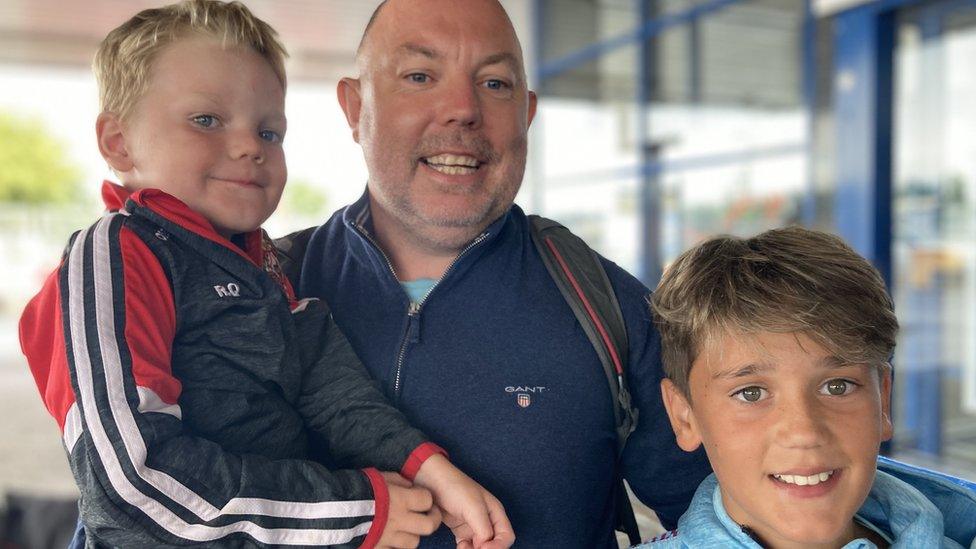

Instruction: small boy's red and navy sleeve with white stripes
[20,214,388,547]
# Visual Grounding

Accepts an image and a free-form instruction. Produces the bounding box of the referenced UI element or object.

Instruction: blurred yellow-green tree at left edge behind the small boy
[0,113,80,204]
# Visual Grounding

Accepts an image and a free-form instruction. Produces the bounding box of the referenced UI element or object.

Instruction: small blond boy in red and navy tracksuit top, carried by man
[21,0,513,547]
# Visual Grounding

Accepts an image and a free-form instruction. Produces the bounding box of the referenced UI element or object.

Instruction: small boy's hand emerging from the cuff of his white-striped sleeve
[376,473,441,549]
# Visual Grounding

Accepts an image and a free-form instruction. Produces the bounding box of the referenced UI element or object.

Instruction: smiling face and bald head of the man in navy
[339,0,535,250]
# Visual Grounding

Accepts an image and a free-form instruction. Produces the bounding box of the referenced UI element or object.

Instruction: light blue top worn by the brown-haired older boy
[635,458,976,549]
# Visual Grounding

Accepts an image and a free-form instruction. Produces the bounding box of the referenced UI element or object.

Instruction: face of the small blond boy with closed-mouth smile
[109,37,287,237]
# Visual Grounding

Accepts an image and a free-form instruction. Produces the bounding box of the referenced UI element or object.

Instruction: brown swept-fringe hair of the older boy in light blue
[651,227,898,398]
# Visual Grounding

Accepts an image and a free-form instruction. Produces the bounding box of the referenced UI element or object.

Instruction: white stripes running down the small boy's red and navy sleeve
[68,214,374,545]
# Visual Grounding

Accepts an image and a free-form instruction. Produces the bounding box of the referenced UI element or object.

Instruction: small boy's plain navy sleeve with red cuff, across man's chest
[295,300,446,480]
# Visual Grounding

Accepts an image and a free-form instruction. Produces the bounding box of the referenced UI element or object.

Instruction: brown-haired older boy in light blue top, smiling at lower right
[646,228,976,548]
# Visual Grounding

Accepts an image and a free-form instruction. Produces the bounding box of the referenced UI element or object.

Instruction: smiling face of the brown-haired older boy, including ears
[662,333,891,547]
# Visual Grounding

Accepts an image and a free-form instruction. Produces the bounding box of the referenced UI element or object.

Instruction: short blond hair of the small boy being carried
[92,0,288,119]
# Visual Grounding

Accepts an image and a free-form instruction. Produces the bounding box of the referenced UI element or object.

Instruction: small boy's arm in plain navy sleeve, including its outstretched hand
[296,301,515,548]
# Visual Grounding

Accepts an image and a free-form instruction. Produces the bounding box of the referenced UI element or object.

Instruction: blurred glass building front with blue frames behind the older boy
[530,0,976,475]
